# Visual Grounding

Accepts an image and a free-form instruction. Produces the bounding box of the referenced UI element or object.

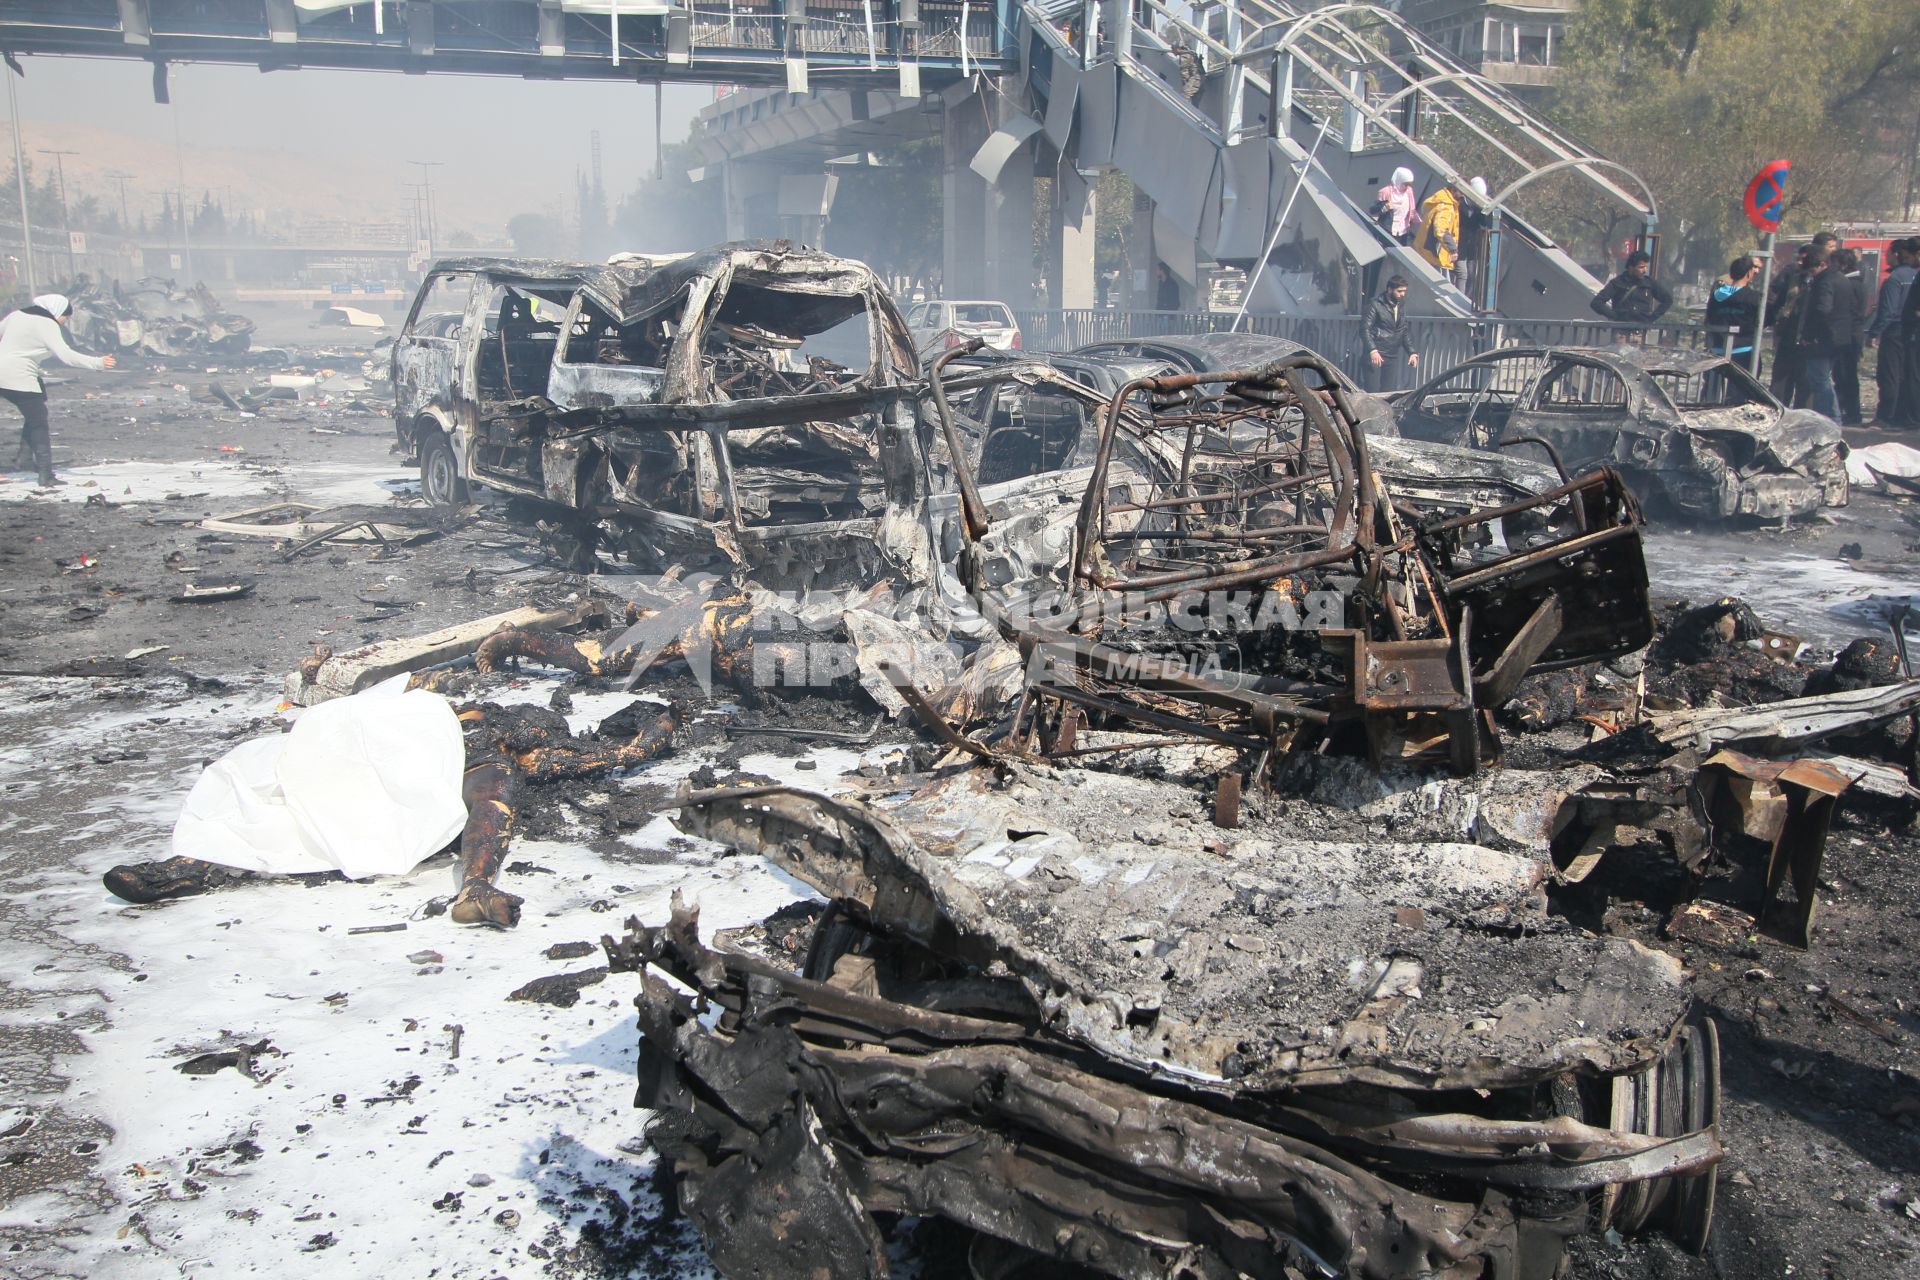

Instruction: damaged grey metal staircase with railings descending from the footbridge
[1002,0,1655,319]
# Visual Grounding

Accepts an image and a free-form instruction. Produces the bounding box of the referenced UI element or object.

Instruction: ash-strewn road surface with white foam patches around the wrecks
[0,349,1920,1280]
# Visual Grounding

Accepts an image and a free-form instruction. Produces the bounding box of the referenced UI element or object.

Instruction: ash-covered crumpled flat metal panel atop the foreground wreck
[682,770,1686,1088]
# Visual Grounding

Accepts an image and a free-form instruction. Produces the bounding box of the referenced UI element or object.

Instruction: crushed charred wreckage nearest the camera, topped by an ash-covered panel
[607,766,1718,1280]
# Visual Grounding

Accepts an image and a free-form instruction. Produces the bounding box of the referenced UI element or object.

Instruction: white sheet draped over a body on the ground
[173,676,467,879]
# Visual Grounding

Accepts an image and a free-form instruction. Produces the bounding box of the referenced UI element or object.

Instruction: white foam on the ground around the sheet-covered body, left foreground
[0,681,879,1280]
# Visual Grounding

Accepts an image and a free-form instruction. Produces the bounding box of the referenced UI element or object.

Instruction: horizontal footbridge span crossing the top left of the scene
[0,0,1008,88]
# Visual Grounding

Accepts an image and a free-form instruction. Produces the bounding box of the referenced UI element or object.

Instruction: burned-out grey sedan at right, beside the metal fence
[1394,347,1847,520]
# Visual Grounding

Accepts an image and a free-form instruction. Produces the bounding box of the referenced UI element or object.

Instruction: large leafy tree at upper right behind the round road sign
[1549,0,1920,270]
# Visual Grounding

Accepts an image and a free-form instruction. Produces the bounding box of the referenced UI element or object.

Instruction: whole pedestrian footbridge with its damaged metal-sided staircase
[0,0,1655,319]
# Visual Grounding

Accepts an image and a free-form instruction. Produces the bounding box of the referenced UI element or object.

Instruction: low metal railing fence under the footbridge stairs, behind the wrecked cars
[1014,307,1726,372]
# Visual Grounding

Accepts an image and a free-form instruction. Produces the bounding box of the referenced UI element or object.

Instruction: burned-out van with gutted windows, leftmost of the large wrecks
[394,242,925,578]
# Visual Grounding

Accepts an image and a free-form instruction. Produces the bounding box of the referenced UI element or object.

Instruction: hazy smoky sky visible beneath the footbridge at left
[0,58,712,237]
